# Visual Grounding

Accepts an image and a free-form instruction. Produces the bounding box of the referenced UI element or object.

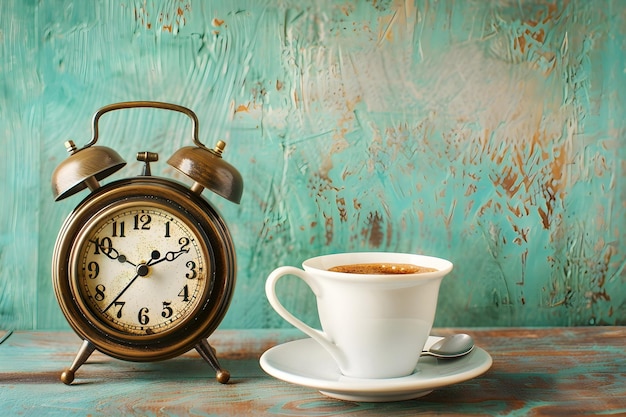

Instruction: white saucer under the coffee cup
[260,336,492,402]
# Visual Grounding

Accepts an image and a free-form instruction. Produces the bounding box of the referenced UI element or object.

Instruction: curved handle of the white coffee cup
[265,266,343,363]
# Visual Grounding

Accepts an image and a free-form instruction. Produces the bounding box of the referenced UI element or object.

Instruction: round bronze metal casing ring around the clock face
[52,176,236,361]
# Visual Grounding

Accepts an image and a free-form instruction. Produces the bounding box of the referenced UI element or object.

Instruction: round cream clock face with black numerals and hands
[70,201,211,336]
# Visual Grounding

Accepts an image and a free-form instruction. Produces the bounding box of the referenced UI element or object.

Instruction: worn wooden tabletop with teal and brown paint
[0,327,626,417]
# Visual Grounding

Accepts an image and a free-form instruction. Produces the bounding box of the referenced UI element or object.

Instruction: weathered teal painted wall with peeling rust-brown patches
[0,0,626,329]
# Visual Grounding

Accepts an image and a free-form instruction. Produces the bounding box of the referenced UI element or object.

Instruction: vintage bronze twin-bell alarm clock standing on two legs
[52,101,243,384]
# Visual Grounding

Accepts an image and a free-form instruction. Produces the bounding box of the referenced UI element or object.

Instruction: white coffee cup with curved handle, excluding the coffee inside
[265,252,452,379]
